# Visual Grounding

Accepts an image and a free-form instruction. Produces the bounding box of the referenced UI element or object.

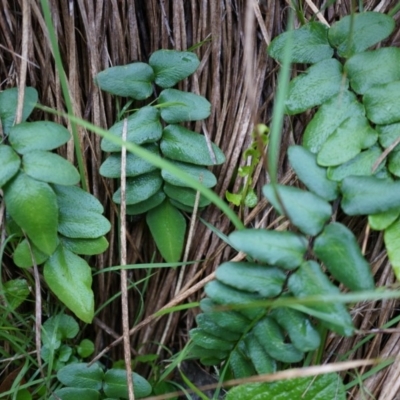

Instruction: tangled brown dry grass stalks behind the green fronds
[0,0,400,400]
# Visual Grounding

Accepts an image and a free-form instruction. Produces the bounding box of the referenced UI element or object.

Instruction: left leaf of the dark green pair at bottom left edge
[57,363,104,390]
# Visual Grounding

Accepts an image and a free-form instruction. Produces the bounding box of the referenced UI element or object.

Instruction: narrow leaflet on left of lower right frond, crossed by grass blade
[204,281,265,320]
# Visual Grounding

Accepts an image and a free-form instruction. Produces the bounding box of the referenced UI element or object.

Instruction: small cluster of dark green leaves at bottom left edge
[52,363,152,400]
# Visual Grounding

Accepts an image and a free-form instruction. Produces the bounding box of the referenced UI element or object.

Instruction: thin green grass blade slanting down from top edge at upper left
[40,0,88,191]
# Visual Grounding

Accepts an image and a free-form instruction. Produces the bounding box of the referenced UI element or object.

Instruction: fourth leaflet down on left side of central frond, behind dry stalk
[113,171,163,205]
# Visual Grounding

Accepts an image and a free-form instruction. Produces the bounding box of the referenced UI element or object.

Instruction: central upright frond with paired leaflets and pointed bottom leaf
[95,50,225,261]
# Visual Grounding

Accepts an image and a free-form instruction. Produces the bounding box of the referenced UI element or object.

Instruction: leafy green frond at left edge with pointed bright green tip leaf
[0,88,111,322]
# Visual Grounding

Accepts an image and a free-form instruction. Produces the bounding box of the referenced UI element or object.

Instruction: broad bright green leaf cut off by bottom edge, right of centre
[226,373,346,400]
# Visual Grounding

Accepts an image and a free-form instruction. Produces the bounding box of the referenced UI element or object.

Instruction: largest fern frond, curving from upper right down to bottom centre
[190,12,400,388]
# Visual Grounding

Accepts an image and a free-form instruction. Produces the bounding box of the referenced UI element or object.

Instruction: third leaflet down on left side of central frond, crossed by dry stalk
[100,144,159,178]
